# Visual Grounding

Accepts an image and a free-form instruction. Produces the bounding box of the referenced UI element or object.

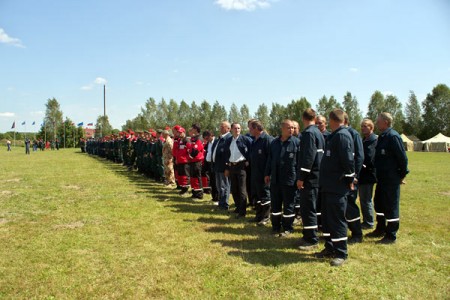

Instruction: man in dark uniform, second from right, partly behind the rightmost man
[358,119,377,229]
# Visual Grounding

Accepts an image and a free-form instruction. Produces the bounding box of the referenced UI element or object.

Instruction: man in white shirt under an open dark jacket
[224,123,251,219]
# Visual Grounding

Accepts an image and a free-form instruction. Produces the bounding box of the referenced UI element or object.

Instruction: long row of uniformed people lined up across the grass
[84,109,408,266]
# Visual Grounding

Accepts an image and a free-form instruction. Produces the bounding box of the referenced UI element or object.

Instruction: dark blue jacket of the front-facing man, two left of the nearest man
[264,136,300,186]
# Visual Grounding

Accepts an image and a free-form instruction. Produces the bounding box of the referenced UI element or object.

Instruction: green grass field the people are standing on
[0,147,450,299]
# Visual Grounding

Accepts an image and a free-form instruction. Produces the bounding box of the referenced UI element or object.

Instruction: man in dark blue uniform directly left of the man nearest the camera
[297,108,325,250]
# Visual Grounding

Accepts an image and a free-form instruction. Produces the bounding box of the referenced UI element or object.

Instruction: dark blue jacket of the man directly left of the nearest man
[297,125,325,187]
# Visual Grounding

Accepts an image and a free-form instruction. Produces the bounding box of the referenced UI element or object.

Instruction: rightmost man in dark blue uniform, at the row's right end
[368,112,409,244]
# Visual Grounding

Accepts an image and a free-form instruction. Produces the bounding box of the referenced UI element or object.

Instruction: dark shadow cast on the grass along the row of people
[84,156,317,266]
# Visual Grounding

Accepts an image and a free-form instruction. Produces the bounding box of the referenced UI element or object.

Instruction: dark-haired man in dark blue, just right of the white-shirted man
[248,120,273,226]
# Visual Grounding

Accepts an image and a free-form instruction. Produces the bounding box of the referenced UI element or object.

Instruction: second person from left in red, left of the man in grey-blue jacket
[186,124,204,199]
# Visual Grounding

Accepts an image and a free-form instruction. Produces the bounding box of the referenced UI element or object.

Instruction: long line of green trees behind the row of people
[122,84,450,140]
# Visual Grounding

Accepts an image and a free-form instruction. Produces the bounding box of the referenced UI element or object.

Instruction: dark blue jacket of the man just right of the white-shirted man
[250,132,274,180]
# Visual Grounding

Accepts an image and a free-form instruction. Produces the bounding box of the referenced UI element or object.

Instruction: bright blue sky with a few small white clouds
[0,0,450,132]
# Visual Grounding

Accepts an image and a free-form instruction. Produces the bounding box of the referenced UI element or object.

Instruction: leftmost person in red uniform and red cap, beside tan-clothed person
[173,127,190,195]
